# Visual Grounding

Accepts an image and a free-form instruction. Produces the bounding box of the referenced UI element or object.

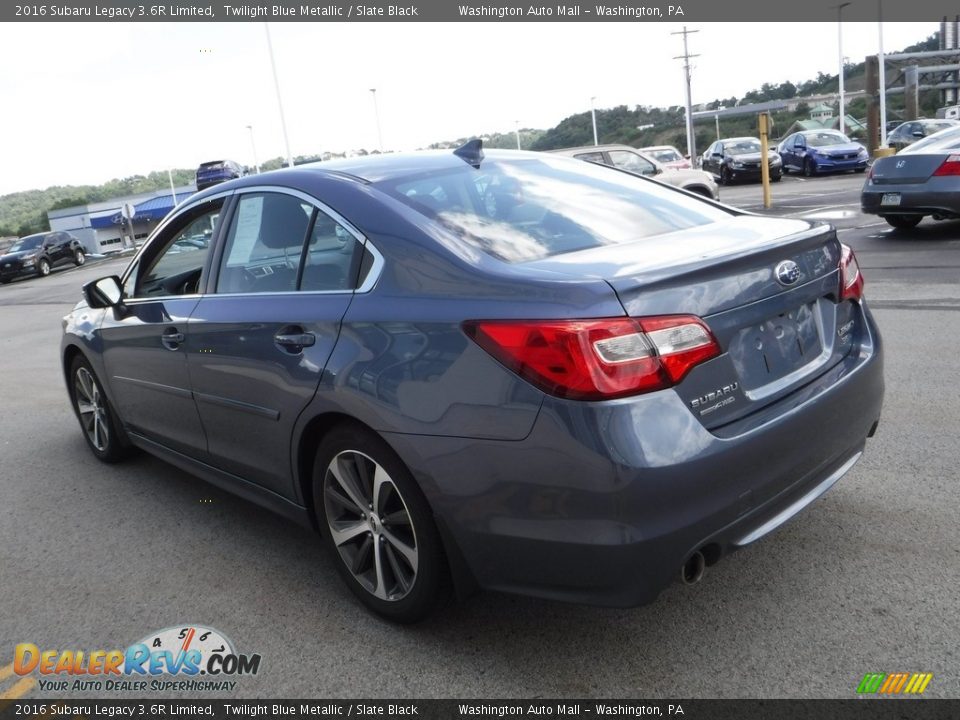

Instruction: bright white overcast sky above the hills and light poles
[0,22,939,194]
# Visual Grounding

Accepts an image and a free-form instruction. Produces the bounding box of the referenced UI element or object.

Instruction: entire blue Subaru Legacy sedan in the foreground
[62,141,883,622]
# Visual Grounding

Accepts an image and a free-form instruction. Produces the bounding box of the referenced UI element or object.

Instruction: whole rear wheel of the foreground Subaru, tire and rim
[313,424,450,623]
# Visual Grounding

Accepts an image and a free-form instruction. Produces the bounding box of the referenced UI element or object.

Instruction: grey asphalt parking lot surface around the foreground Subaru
[0,175,960,699]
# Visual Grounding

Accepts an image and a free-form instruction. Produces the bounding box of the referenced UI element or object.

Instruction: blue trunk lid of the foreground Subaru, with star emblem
[524,215,853,428]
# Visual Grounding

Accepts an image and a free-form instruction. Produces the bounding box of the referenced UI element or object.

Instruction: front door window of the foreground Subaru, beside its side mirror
[131,199,223,298]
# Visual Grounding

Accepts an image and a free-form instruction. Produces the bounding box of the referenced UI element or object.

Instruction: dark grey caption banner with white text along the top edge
[0,0,960,23]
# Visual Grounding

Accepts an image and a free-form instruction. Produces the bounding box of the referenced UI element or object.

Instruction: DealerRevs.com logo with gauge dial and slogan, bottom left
[13,624,260,693]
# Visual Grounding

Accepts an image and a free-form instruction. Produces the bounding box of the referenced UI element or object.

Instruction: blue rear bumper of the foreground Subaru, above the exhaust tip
[386,300,883,607]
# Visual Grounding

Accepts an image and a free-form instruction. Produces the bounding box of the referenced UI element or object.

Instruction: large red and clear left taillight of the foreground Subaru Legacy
[464,315,720,400]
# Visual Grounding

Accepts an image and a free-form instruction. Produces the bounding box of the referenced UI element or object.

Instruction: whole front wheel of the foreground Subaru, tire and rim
[67,355,133,463]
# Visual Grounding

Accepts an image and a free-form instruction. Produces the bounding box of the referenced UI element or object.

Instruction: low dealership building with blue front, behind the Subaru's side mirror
[47,185,197,254]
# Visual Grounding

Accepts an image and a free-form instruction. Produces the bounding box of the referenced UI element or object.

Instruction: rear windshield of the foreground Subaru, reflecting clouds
[376,157,732,263]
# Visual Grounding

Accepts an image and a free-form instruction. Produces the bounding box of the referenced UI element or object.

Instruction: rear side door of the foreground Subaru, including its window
[188,188,374,497]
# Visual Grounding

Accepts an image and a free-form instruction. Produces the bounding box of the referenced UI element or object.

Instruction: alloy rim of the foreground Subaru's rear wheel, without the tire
[323,450,419,602]
